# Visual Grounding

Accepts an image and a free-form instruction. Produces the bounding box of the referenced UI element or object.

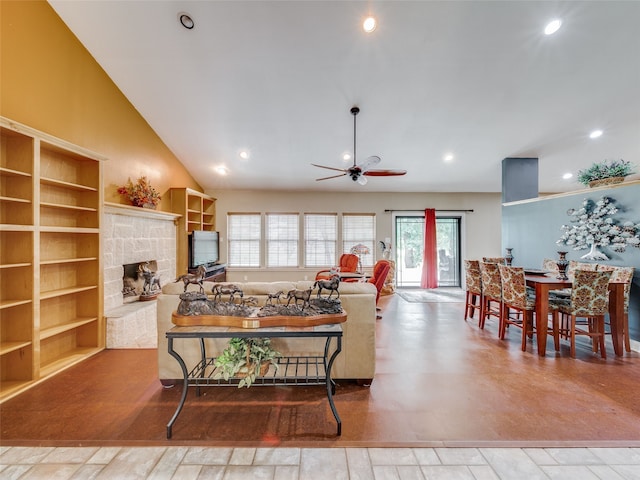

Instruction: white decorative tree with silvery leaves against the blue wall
[556,197,640,260]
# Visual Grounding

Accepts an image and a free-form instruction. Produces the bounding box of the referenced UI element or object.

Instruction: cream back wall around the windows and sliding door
[212,190,502,281]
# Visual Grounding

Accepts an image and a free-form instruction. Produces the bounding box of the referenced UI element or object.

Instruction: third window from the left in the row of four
[304,213,338,267]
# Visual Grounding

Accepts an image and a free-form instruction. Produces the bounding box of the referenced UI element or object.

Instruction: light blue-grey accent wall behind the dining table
[502,181,640,341]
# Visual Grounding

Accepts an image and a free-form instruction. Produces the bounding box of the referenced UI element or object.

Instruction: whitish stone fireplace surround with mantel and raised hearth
[102,203,179,348]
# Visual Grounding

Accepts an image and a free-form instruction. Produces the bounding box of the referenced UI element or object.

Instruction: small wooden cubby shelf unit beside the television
[170,188,216,275]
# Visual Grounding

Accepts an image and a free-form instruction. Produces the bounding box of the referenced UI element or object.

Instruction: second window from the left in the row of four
[265,213,300,267]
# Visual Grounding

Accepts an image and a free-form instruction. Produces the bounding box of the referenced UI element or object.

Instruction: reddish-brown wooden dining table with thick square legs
[525,270,625,357]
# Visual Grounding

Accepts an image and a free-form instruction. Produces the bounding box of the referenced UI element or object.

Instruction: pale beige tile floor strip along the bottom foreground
[0,447,640,480]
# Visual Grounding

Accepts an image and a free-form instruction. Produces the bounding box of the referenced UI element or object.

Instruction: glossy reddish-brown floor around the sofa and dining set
[0,295,640,447]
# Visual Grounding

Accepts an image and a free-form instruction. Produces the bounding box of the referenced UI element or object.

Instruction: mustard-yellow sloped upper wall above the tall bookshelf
[0,0,202,210]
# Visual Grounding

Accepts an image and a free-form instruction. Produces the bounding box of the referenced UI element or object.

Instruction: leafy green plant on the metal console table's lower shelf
[214,338,281,388]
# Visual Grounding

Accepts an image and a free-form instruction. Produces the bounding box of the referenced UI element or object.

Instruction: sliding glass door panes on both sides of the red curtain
[395,215,461,288]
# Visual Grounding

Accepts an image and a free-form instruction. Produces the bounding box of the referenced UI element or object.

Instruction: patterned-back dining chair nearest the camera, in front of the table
[549,269,612,358]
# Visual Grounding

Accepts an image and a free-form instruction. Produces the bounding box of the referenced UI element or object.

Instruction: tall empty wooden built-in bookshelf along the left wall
[0,117,105,401]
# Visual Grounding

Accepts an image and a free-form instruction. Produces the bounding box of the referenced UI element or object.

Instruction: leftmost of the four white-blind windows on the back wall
[227,213,261,267]
